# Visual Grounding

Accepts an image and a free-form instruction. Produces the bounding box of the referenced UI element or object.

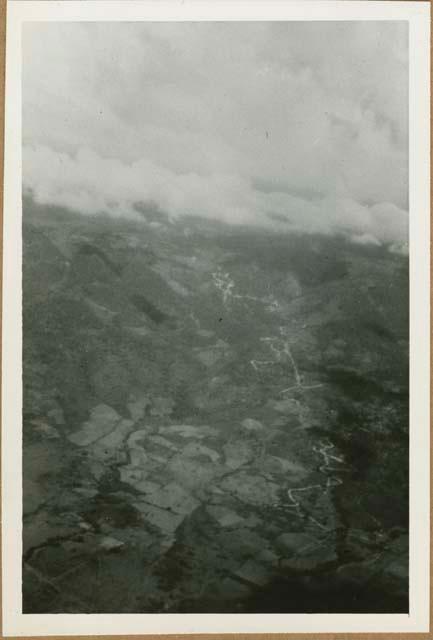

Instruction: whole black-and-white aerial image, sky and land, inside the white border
[2,3,428,636]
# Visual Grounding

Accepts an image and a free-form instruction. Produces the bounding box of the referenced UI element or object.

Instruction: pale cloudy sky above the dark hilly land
[23,21,408,244]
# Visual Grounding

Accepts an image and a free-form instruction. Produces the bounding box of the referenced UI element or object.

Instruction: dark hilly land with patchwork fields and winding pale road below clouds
[23,195,409,613]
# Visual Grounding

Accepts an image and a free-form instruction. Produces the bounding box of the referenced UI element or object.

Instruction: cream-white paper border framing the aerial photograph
[2,0,430,636]
